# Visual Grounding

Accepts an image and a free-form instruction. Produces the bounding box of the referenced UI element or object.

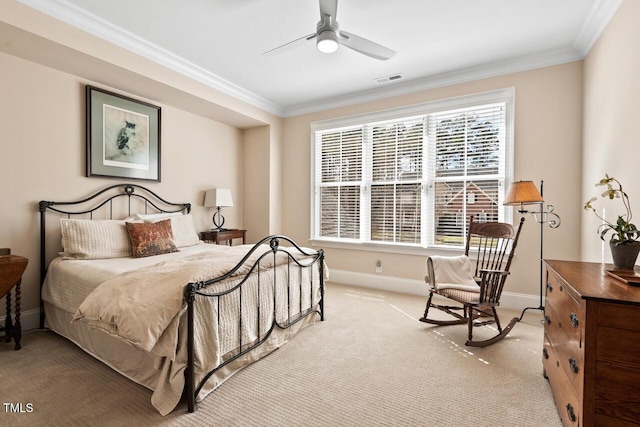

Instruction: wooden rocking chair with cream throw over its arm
[420,216,524,347]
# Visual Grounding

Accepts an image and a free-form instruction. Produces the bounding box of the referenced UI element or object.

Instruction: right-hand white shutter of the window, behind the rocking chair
[428,103,506,246]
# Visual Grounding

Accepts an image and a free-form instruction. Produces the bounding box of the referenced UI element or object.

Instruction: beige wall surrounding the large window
[282,62,582,295]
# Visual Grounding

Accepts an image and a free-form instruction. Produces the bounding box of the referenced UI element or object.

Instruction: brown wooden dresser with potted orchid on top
[542,260,640,427]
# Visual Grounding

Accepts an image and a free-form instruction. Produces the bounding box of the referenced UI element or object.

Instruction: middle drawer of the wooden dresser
[544,303,584,396]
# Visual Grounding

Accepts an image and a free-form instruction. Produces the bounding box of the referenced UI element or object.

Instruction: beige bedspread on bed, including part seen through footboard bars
[46,245,320,415]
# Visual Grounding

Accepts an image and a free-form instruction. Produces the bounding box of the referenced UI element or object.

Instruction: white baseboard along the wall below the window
[329,270,544,311]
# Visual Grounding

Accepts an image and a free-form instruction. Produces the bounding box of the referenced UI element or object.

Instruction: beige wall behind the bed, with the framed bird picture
[0,53,244,318]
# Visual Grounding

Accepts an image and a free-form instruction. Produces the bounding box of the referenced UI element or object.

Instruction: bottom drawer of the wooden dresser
[542,334,582,427]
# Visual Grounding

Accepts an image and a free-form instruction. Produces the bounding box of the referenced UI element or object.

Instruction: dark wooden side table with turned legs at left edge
[0,255,29,350]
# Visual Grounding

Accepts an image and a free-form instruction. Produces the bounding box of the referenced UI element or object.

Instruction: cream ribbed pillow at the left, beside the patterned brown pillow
[60,218,131,259]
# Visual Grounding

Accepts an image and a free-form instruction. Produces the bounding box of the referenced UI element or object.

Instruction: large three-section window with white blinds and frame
[311,89,513,252]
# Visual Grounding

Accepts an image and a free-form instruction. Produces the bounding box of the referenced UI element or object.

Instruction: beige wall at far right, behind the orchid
[581,0,640,262]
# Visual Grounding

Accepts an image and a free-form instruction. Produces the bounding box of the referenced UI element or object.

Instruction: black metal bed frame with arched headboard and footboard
[39,184,324,412]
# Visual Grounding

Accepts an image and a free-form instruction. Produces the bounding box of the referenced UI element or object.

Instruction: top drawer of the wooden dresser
[545,272,584,347]
